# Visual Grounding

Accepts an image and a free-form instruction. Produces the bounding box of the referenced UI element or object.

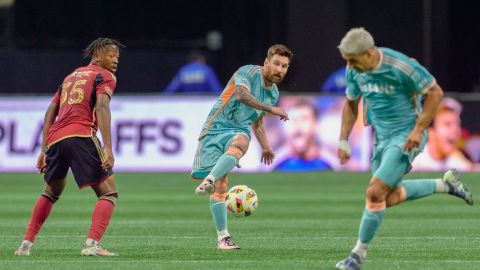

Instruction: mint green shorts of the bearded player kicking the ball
[190,130,250,179]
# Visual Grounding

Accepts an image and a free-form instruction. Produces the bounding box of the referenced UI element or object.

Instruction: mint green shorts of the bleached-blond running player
[371,133,427,188]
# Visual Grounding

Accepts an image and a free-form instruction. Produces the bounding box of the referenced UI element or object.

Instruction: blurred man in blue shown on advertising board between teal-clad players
[275,98,332,172]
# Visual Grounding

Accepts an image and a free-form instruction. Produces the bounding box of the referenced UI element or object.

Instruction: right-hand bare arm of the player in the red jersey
[95,94,115,170]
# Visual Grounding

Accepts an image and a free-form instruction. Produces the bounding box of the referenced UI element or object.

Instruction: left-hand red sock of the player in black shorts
[23,195,53,243]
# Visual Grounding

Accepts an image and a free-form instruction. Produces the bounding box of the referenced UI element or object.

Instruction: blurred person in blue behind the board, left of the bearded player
[163,51,222,94]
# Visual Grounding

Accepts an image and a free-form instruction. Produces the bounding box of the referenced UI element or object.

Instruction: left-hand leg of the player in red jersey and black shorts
[15,141,69,256]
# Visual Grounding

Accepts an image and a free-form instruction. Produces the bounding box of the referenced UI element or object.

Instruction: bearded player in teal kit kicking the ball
[191,44,293,249]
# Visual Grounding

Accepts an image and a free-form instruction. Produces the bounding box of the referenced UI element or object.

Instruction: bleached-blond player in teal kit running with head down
[336,28,473,269]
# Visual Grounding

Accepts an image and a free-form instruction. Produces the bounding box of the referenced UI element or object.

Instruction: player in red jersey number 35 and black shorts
[15,38,124,256]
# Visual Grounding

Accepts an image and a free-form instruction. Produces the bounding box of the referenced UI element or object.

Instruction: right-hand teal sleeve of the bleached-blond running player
[405,59,436,94]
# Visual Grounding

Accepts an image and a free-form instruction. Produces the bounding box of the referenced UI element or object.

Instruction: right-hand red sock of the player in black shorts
[88,199,115,242]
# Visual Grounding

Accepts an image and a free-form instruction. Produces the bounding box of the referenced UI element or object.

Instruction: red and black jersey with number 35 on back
[47,64,116,146]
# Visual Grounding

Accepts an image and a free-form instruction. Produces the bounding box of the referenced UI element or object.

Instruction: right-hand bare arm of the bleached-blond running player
[404,84,443,151]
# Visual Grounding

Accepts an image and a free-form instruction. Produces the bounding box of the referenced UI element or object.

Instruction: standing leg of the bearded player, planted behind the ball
[210,175,240,250]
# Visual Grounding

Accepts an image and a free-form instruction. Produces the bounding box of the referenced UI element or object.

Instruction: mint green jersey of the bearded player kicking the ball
[200,65,279,138]
